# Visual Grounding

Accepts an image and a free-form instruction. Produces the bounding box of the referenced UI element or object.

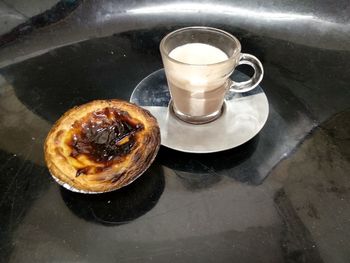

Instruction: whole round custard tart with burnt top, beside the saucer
[44,100,160,193]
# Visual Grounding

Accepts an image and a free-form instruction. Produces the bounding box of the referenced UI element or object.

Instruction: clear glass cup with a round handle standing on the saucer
[160,27,264,124]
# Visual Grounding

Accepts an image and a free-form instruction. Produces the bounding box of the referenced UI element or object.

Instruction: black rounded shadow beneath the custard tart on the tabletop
[60,163,165,226]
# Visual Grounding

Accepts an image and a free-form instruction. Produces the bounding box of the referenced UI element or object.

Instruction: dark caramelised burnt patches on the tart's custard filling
[68,108,143,176]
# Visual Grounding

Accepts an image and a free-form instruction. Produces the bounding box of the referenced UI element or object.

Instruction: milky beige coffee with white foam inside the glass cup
[167,43,229,116]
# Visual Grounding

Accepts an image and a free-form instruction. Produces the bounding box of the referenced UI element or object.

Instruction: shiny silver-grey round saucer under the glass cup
[130,69,269,153]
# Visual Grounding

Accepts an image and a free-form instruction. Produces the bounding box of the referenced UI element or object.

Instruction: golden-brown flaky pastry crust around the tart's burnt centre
[44,100,160,193]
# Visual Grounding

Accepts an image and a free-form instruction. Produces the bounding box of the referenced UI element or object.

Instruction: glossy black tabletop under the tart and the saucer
[0,1,350,262]
